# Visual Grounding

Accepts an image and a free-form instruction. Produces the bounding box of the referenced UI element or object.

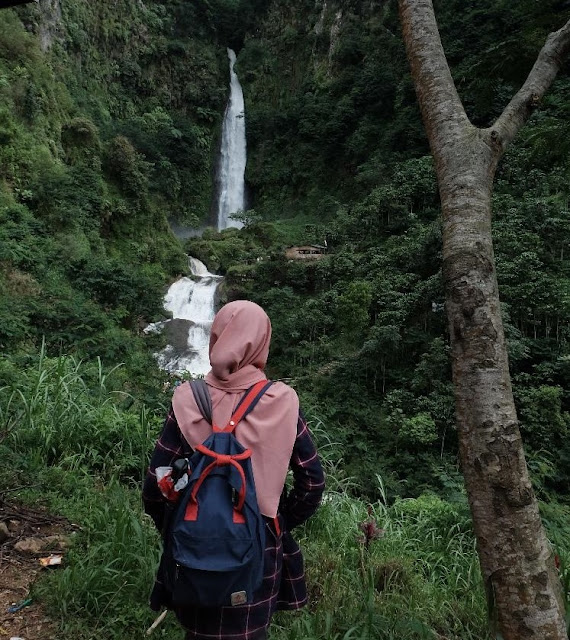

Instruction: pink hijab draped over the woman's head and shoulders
[172,300,299,518]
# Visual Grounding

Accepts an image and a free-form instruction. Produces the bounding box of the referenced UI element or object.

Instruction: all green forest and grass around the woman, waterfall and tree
[0,0,570,640]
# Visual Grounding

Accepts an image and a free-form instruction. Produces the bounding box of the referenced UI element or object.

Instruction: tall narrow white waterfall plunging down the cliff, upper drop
[218,49,247,231]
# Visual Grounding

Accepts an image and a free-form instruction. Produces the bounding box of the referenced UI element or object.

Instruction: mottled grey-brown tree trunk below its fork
[440,145,568,640]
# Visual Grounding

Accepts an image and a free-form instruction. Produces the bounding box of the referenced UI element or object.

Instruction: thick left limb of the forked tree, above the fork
[399,0,469,160]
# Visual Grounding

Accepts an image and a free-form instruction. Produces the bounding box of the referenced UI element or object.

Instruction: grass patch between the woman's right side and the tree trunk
[273,493,491,640]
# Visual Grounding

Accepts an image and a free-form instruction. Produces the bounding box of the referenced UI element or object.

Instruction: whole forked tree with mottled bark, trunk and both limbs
[399,0,570,640]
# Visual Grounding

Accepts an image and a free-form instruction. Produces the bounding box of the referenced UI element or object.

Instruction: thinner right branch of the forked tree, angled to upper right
[490,20,570,154]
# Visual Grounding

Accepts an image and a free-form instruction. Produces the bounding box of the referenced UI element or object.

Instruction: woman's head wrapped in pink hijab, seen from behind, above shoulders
[210,300,271,380]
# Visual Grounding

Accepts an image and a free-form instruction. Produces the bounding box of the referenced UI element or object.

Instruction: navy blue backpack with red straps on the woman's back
[163,380,272,607]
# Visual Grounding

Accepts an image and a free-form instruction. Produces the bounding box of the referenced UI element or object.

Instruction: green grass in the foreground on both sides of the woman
[0,356,570,640]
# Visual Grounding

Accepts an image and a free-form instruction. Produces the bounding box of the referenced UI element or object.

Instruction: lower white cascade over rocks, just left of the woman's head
[145,257,222,376]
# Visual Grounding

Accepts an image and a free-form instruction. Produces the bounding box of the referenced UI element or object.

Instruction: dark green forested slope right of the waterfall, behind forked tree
[187,2,570,495]
